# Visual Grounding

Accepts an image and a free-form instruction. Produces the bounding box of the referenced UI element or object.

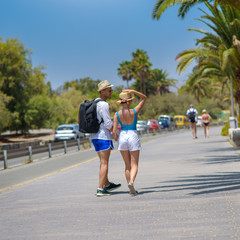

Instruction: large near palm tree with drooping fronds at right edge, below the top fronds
[174,2,240,103]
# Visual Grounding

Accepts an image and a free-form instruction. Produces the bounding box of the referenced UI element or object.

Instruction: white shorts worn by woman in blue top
[118,130,141,152]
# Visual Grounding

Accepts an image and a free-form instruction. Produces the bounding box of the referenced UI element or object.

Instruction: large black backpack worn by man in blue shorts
[78,99,104,133]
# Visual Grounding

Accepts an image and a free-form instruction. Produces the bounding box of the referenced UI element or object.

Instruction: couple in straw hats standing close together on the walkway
[91,80,147,196]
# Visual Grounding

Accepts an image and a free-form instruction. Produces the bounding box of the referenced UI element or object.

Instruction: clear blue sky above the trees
[0,0,204,89]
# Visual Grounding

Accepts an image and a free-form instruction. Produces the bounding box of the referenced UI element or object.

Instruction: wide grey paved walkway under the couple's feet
[0,127,240,240]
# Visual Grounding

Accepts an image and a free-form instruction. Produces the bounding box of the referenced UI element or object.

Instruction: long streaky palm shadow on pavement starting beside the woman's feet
[142,172,240,195]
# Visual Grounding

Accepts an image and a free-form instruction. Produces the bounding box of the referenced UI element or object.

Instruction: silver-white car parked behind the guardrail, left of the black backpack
[54,124,85,141]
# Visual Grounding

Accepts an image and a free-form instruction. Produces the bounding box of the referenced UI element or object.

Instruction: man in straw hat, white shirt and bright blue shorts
[91,80,121,196]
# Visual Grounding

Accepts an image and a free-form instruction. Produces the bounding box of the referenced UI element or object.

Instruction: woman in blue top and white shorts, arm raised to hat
[113,89,147,196]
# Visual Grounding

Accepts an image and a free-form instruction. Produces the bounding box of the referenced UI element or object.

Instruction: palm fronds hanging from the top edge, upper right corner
[152,0,240,19]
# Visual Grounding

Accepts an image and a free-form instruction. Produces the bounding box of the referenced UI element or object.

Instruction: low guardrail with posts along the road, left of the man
[0,138,91,169]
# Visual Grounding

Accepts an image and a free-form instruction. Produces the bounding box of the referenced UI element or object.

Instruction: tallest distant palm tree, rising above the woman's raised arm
[132,49,152,94]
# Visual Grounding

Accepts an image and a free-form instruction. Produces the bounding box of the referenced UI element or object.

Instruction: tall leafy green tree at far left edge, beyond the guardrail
[0,39,49,132]
